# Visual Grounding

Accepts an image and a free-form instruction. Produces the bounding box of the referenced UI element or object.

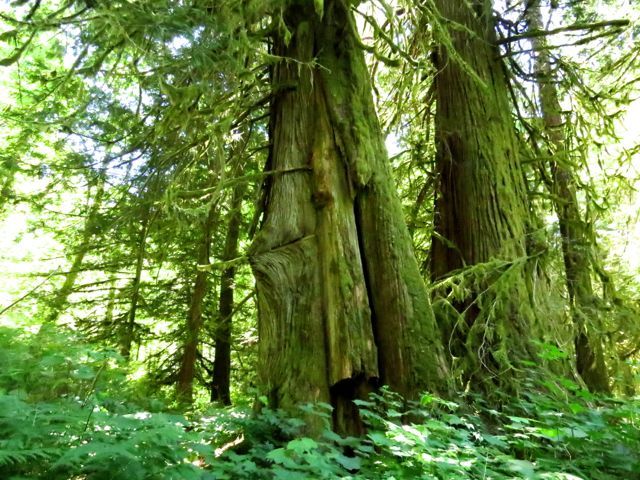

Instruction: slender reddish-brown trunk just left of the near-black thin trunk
[177,203,218,404]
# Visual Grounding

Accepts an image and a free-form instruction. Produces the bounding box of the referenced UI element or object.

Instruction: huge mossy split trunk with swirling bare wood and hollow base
[251,0,446,432]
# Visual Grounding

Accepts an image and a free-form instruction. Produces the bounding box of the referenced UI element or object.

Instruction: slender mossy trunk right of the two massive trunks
[527,0,609,392]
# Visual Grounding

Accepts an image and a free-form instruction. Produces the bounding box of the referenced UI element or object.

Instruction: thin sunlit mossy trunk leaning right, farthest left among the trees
[47,166,106,322]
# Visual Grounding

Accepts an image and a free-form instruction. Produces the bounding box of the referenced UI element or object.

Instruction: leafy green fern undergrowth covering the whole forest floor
[0,327,640,480]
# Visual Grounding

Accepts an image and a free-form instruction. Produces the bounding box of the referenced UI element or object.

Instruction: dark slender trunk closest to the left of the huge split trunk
[211,184,244,405]
